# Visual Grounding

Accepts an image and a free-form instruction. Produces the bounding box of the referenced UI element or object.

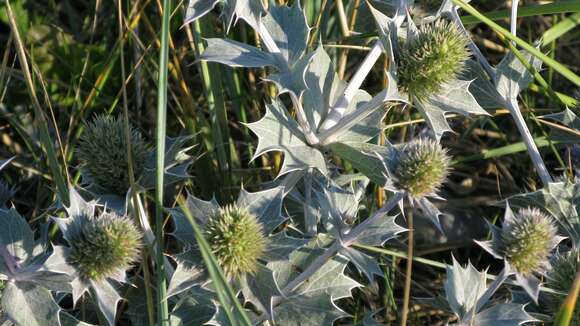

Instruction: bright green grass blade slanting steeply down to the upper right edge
[452,0,580,86]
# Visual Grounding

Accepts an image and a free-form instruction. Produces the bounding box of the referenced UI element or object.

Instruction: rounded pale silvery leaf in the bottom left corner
[2,282,61,326]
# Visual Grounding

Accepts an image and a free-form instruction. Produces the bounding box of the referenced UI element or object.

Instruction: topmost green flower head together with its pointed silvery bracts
[369,2,489,139]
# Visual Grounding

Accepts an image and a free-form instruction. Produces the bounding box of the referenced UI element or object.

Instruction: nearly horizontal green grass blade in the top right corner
[461,0,580,25]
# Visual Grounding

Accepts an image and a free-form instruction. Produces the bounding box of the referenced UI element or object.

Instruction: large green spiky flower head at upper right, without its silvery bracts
[397,20,470,100]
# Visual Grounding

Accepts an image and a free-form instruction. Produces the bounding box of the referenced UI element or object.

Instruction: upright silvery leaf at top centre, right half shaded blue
[262,1,310,66]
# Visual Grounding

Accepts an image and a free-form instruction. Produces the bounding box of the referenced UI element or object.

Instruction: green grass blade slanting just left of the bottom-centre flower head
[178,197,252,326]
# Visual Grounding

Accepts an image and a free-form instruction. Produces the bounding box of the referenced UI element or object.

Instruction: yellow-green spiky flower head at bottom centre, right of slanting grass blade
[205,205,268,278]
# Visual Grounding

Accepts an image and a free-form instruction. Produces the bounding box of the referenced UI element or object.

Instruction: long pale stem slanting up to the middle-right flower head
[282,193,403,296]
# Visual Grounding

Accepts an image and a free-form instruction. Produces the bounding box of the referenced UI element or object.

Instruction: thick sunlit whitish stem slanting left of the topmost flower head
[320,40,383,131]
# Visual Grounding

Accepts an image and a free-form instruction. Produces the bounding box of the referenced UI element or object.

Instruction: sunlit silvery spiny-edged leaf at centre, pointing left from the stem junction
[247,102,326,176]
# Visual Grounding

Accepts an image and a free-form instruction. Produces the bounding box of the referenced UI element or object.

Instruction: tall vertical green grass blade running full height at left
[155,0,171,326]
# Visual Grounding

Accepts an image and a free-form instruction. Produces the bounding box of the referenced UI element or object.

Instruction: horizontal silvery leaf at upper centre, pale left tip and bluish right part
[200,38,277,68]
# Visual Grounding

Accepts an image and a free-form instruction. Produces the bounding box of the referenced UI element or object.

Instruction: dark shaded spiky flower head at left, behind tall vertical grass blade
[78,115,149,195]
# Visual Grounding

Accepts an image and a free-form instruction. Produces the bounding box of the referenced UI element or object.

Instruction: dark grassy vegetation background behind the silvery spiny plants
[0,0,580,324]
